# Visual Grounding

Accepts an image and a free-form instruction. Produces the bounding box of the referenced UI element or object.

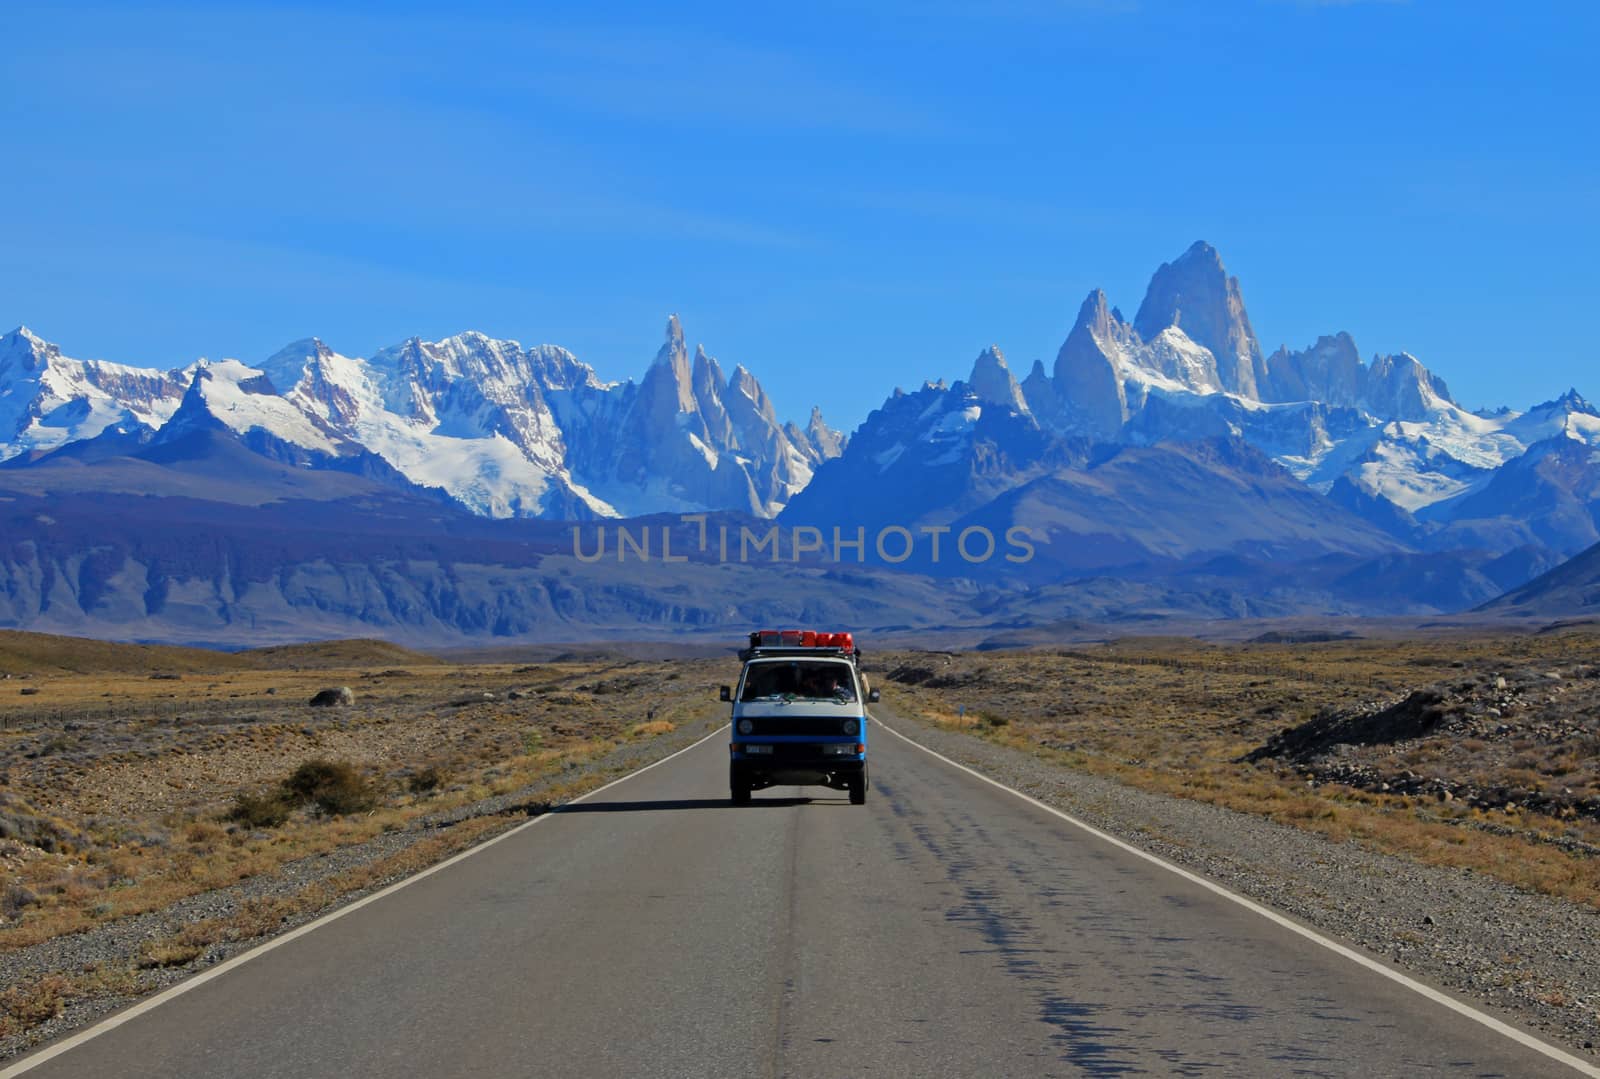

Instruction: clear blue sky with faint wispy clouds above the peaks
[0,0,1600,427]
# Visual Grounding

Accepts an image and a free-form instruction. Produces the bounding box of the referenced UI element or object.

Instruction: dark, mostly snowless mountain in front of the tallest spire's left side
[781,348,1405,584]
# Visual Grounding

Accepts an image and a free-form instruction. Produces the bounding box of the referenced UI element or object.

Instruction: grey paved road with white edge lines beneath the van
[9,710,1574,1079]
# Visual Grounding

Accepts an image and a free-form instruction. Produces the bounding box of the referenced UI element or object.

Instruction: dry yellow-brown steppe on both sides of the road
[0,626,1600,1055]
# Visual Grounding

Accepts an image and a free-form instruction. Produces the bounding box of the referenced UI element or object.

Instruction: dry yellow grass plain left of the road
[0,640,728,947]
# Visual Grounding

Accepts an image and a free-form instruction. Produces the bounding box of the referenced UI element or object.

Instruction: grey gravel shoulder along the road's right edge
[878,706,1600,1063]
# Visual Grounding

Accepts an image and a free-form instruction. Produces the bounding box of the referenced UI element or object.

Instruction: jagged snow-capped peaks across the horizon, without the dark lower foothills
[0,242,1600,582]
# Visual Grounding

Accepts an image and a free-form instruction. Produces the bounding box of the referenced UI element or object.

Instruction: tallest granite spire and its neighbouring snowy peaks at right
[1021,242,1600,534]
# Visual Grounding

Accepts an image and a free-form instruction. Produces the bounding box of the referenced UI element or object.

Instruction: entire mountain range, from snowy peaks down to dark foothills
[0,236,1600,640]
